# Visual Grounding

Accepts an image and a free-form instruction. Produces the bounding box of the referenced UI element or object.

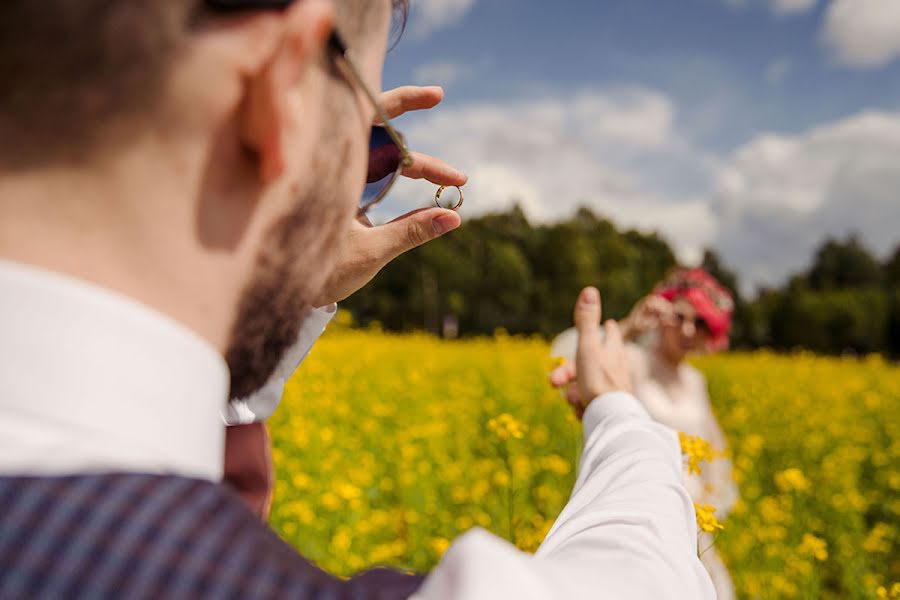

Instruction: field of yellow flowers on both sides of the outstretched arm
[270,327,900,598]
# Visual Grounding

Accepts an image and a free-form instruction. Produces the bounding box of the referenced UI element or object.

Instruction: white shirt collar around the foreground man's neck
[0,260,229,481]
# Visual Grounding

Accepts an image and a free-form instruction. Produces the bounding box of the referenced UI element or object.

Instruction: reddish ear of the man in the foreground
[239,0,334,183]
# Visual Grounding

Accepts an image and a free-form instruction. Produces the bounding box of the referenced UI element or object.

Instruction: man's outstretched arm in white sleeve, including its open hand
[416,290,715,600]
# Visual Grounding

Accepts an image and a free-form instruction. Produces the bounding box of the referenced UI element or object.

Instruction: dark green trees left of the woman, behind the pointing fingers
[344,208,675,336]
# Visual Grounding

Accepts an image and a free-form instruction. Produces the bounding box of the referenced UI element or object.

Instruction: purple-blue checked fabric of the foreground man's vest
[0,474,422,600]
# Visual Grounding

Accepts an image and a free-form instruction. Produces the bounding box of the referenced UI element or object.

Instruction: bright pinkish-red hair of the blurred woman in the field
[656,268,734,351]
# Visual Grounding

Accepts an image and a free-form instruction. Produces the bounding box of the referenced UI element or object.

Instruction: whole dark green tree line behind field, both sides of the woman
[342,207,900,355]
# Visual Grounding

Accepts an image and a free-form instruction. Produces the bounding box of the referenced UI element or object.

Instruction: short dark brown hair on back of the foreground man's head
[0,0,409,171]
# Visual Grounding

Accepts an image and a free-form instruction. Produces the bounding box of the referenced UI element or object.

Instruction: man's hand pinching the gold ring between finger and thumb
[316,86,468,306]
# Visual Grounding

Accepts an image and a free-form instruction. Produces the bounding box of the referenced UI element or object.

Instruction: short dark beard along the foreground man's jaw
[225,115,352,399]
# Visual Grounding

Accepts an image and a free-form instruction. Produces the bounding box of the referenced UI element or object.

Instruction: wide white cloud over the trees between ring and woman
[370,88,716,261]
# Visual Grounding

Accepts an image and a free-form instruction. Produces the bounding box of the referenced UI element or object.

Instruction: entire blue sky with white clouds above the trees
[372,0,900,290]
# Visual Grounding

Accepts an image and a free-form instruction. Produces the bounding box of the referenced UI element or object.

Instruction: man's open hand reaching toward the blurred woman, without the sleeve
[550,287,631,418]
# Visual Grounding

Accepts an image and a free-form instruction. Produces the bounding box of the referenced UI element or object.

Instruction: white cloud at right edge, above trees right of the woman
[712,112,900,288]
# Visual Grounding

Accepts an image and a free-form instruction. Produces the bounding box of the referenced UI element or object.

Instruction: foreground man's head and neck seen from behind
[0,0,406,395]
